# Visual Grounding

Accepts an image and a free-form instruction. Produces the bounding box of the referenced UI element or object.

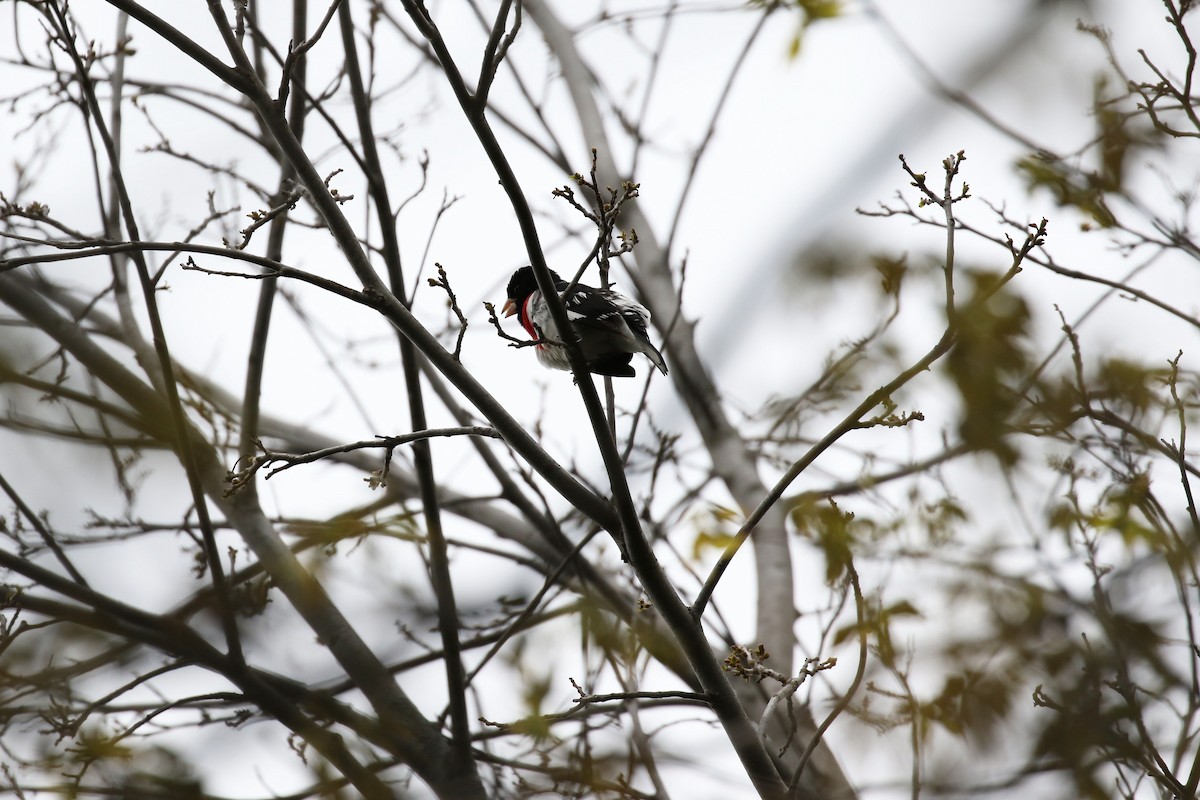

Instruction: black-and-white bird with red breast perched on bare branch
[504,266,667,378]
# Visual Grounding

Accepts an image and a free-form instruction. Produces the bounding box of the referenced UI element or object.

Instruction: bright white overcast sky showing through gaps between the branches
[0,0,1200,798]
